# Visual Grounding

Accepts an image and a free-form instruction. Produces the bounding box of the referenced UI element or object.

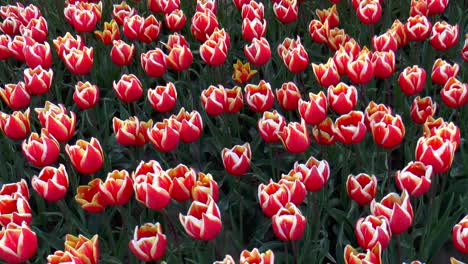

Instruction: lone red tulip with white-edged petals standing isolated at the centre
[221,143,252,176]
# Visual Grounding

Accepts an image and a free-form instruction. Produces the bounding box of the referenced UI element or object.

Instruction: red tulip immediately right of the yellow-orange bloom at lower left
[99,170,133,205]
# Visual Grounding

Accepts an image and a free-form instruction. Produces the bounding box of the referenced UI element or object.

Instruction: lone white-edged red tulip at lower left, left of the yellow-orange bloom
[31,164,68,202]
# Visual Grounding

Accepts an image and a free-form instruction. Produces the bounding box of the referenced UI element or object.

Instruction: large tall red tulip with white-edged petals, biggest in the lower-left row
[132,160,172,210]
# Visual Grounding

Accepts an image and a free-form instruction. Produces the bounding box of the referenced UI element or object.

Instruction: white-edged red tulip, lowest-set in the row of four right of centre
[298,91,328,125]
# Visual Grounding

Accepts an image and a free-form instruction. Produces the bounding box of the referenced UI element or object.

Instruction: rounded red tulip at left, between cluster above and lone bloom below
[21,129,60,167]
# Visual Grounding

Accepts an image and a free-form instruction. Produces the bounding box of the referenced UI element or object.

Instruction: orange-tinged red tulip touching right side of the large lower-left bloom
[166,164,197,202]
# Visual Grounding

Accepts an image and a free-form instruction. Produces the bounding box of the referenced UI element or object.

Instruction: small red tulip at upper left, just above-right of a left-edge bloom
[23,65,54,95]
